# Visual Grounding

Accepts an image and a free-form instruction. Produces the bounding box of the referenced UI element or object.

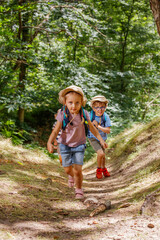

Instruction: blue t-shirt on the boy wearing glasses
[88,113,111,141]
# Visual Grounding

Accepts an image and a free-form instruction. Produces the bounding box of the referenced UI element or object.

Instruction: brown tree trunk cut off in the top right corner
[150,0,160,35]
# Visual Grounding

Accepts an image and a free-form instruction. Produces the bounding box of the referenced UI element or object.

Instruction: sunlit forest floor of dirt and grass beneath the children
[0,119,160,240]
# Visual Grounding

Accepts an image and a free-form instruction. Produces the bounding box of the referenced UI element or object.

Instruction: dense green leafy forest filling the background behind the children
[0,0,160,142]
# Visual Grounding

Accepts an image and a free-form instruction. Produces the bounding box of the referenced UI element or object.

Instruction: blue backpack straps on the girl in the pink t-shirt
[61,106,88,136]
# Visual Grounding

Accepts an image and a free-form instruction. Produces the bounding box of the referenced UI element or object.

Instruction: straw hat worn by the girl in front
[59,85,87,107]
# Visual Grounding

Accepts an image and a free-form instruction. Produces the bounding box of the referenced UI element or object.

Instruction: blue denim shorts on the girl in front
[59,143,86,167]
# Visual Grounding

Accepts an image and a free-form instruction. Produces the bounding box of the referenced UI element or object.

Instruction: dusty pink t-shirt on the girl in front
[56,110,89,147]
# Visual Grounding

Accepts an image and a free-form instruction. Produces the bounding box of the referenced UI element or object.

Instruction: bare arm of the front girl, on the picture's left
[47,121,62,153]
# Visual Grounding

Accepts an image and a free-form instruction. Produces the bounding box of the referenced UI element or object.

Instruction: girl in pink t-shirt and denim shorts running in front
[47,85,107,199]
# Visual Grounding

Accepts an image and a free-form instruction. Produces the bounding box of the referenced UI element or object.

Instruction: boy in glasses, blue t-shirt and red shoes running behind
[88,95,111,179]
